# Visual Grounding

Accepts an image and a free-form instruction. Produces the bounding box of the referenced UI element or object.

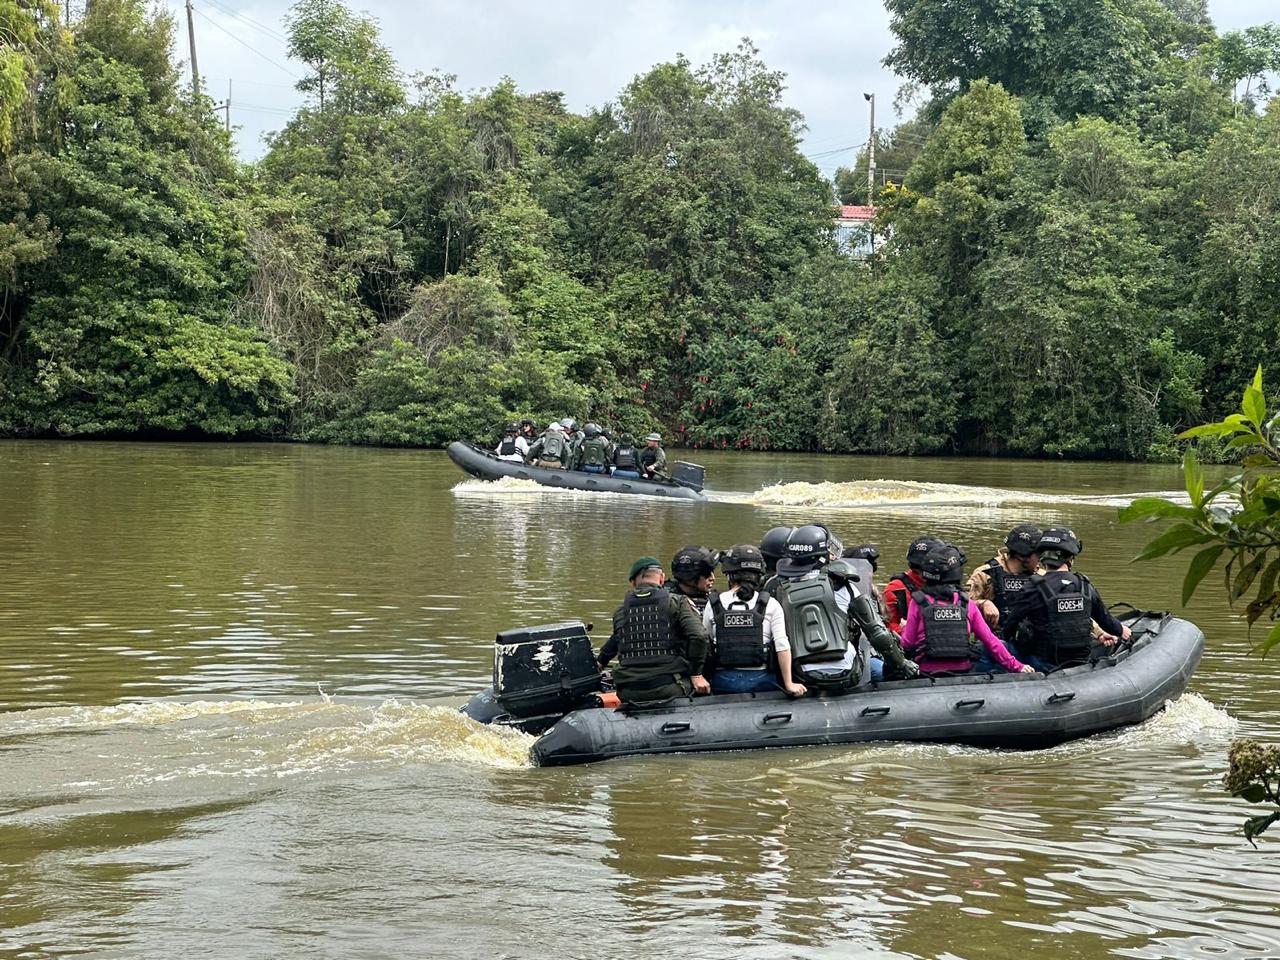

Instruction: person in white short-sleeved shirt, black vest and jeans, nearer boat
[703,543,808,696]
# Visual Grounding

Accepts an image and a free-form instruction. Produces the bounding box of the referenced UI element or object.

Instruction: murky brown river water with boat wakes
[0,443,1280,960]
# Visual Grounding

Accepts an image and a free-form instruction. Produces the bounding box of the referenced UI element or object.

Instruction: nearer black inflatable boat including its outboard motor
[462,612,1204,767]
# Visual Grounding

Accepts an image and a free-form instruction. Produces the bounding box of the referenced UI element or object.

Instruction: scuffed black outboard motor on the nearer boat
[493,620,600,718]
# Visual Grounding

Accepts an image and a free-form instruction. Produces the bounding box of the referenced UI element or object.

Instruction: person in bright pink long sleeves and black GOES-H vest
[902,544,1036,675]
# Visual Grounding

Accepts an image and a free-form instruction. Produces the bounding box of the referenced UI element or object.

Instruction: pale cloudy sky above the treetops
[161,0,1276,170]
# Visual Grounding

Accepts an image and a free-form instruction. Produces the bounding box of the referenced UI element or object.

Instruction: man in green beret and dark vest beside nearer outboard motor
[596,557,710,703]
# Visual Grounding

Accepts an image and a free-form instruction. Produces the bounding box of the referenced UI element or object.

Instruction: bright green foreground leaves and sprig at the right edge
[1120,367,1280,841]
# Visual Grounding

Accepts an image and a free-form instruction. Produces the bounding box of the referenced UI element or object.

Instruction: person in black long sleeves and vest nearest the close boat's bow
[1001,527,1130,672]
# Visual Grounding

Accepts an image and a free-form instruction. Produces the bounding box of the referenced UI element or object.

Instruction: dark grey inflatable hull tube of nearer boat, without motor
[519,614,1204,767]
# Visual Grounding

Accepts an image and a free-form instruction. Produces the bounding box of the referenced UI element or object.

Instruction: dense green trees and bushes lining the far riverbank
[0,0,1280,458]
